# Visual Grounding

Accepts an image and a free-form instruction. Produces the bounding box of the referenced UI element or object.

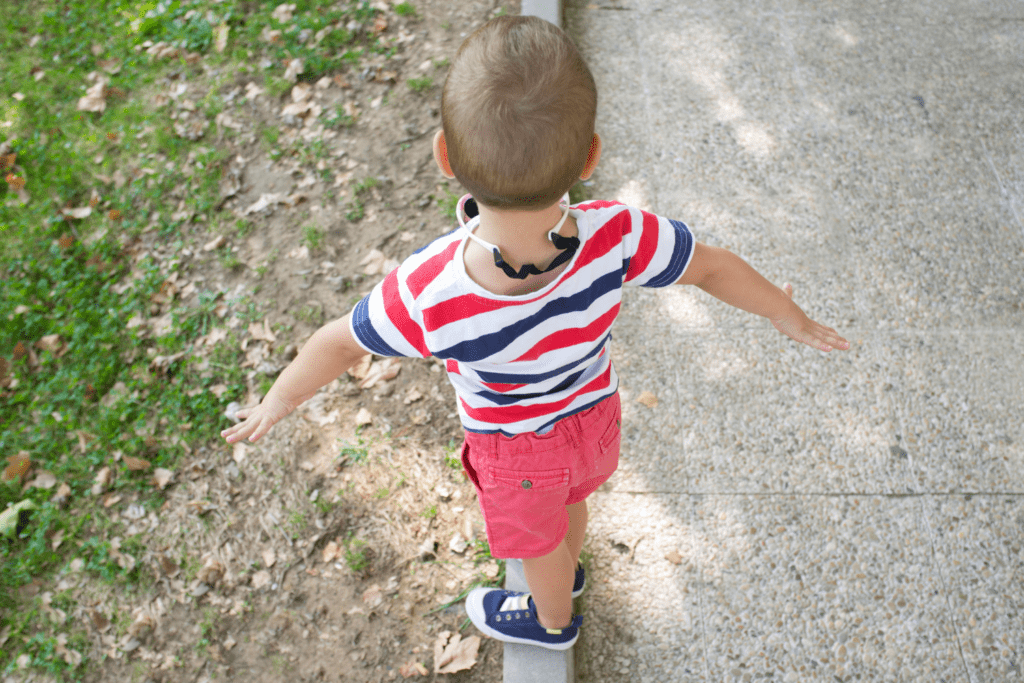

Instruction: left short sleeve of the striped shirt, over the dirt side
[351,267,430,358]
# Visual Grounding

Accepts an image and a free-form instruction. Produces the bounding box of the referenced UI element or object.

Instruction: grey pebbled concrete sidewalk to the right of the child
[564,0,1024,683]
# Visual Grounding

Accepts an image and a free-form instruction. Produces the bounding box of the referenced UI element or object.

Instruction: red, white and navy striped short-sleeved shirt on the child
[351,202,693,436]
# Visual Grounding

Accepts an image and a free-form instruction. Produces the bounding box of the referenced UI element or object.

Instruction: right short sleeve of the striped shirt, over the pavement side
[623,209,693,287]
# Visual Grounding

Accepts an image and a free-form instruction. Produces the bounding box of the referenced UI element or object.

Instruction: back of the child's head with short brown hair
[441,16,597,209]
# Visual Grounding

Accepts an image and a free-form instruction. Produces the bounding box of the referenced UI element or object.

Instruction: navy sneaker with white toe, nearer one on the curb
[466,588,583,650]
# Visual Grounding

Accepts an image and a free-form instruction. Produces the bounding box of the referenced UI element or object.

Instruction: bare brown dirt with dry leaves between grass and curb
[57,0,519,683]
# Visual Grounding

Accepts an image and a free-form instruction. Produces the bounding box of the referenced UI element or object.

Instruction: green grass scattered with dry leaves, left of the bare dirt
[0,0,399,680]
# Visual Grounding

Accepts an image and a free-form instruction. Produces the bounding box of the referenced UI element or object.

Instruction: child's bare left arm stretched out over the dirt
[220,313,367,443]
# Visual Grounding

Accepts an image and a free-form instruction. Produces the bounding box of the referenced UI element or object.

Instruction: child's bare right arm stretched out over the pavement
[676,242,850,351]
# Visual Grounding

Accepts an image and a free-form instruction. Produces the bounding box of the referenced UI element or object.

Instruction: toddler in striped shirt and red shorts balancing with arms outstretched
[222,16,849,649]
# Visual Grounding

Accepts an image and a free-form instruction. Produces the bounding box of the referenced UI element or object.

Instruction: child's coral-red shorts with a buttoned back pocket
[462,393,622,558]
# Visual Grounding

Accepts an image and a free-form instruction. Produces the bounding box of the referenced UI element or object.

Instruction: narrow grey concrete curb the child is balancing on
[502,5,575,683]
